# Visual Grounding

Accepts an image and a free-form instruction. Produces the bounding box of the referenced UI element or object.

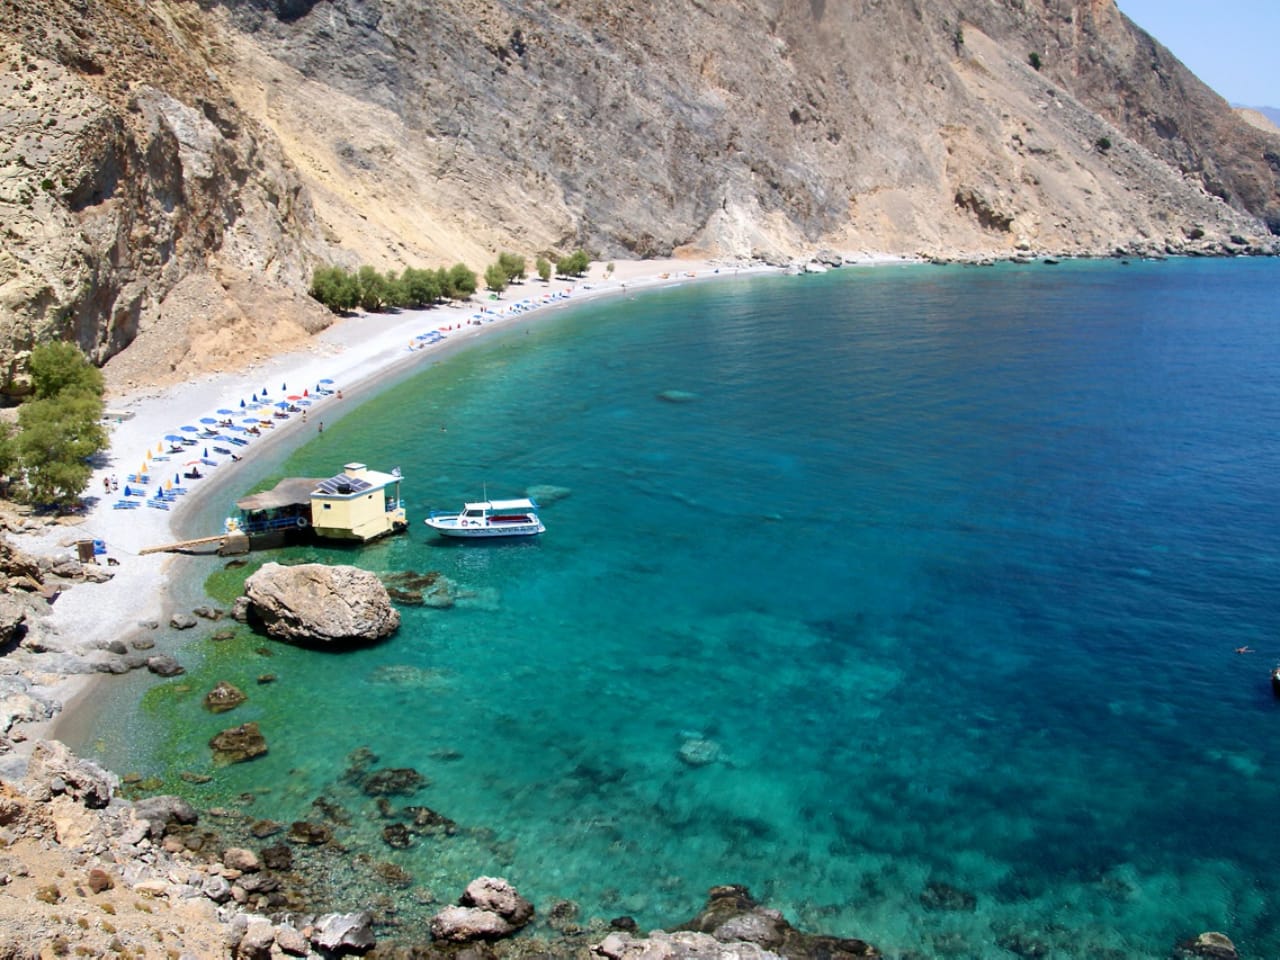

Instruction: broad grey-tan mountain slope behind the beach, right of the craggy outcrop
[204,0,1277,264]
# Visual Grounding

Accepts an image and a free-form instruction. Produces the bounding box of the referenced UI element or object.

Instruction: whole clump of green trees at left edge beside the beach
[0,342,108,507]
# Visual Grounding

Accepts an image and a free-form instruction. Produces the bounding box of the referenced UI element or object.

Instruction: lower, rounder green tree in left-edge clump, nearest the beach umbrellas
[18,389,106,507]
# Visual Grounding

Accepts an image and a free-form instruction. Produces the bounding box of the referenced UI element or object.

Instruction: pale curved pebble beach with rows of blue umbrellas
[14,260,774,740]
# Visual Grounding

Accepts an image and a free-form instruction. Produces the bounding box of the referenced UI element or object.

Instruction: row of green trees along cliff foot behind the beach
[311,250,591,314]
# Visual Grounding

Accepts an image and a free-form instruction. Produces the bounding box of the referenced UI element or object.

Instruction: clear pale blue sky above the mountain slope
[1116,0,1280,108]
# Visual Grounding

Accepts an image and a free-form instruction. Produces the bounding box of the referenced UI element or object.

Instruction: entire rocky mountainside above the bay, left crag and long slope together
[0,0,1280,394]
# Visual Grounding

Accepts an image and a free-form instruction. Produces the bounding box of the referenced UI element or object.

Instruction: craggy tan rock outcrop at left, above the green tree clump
[0,0,328,393]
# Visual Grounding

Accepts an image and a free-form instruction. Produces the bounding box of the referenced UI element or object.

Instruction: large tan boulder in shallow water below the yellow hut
[244,563,399,646]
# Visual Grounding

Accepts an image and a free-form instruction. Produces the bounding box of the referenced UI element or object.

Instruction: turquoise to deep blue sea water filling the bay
[67,259,1280,960]
